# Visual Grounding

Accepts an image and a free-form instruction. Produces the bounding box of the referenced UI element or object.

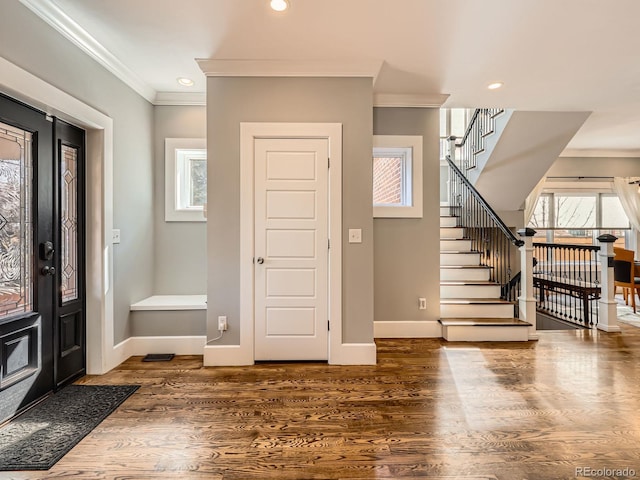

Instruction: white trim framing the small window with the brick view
[372,135,423,218]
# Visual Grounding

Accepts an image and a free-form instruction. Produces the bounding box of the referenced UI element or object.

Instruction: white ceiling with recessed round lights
[21,0,640,156]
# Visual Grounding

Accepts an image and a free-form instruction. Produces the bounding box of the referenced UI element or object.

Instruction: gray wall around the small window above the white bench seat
[153,106,207,295]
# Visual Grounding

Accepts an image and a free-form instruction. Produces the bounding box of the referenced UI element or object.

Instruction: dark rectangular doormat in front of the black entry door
[0,385,139,471]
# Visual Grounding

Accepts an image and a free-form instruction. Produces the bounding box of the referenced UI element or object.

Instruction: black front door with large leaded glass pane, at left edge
[0,95,56,422]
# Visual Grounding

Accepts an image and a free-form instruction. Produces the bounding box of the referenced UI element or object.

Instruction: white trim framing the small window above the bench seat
[164,138,207,222]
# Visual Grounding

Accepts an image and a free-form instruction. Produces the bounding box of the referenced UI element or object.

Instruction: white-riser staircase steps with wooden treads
[439,206,530,342]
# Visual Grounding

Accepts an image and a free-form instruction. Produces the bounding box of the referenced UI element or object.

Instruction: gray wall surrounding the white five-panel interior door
[207,78,373,344]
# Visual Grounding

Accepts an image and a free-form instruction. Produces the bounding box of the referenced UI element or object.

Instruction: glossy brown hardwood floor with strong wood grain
[5,325,640,480]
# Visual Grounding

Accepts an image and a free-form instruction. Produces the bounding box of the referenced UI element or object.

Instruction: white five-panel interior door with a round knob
[254,138,329,360]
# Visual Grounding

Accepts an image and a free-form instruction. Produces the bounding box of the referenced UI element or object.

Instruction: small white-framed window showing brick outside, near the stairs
[373,135,422,218]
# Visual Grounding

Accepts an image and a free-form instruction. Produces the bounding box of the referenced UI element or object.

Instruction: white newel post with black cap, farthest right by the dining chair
[598,234,620,332]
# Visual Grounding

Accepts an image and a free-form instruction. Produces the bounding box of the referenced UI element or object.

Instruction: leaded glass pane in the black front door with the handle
[0,123,33,318]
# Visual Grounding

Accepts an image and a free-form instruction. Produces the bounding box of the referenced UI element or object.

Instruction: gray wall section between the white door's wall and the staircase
[373,108,440,321]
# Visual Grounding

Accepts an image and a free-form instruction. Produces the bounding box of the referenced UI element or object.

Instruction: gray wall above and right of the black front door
[0,0,154,343]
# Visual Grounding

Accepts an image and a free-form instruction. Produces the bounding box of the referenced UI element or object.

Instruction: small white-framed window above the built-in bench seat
[164,138,207,222]
